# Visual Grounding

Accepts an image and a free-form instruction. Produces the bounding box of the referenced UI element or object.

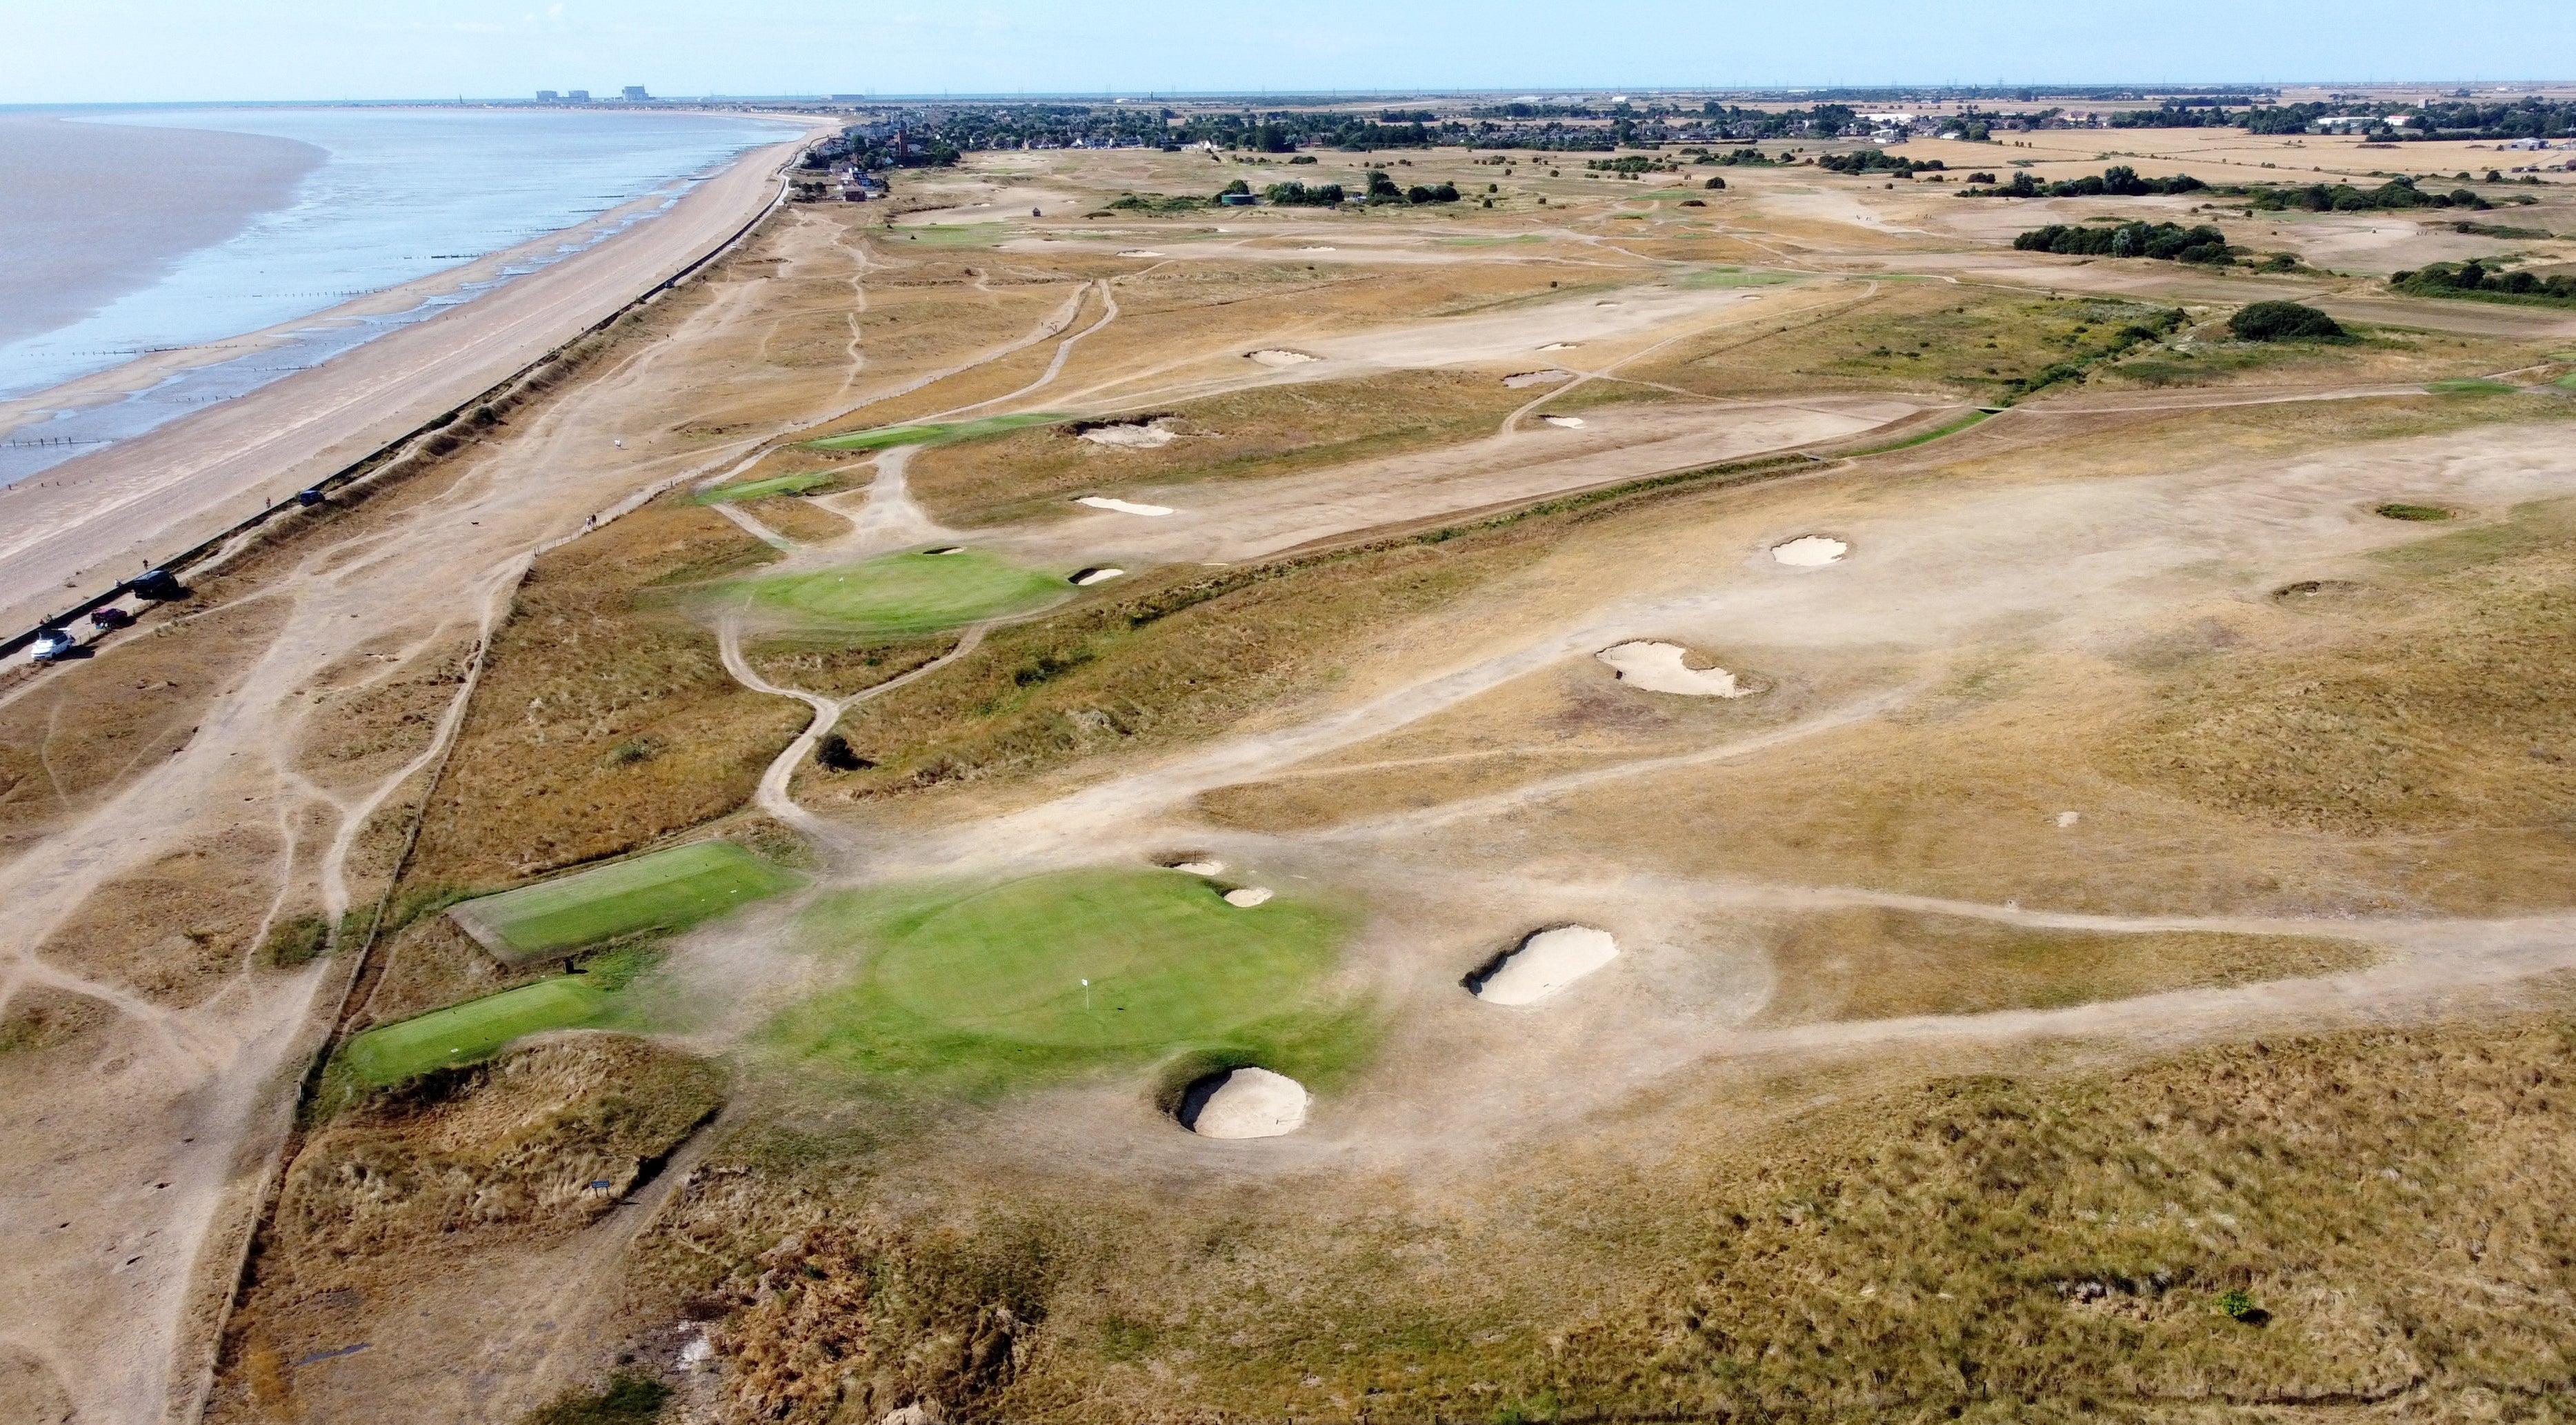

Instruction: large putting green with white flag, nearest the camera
[773,871,1373,1088]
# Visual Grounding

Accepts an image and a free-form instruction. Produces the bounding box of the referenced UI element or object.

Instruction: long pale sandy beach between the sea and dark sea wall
[0,119,837,631]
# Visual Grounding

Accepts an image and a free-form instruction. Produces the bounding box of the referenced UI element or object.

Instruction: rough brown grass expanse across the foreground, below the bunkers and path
[623,1013,2576,1422]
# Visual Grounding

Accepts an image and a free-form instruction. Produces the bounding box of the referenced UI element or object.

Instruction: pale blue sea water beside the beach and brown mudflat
[0,108,799,482]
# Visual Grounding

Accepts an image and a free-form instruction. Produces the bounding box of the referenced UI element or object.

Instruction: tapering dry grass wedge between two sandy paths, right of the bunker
[1762,910,2377,1023]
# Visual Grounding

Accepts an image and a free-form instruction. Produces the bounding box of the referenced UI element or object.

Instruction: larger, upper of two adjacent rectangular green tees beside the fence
[448,840,803,966]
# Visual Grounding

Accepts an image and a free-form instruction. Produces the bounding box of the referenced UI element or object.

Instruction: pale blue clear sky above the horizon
[14,0,2576,103]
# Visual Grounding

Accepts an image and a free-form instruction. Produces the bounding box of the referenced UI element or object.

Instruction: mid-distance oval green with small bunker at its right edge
[716,549,1072,634]
